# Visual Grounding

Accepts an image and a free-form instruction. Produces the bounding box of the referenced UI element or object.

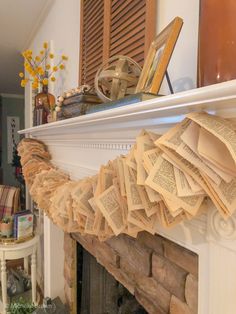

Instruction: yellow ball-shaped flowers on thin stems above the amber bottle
[19,42,68,89]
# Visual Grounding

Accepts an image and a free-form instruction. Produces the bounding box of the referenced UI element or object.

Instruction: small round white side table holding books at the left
[0,236,38,314]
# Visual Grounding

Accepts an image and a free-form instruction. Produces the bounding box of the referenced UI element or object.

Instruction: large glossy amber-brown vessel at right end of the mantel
[198,0,236,87]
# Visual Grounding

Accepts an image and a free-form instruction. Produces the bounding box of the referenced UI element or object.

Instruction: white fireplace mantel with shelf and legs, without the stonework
[20,80,236,314]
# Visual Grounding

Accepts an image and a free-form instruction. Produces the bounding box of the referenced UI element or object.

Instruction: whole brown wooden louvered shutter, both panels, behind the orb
[80,0,156,85]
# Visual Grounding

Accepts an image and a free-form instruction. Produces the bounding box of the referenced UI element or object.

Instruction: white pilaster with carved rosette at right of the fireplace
[206,206,236,314]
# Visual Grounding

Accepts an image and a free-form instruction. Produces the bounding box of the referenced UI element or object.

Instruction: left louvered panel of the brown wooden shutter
[80,0,104,85]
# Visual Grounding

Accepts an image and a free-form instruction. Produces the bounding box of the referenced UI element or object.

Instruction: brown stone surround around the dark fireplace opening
[64,232,198,314]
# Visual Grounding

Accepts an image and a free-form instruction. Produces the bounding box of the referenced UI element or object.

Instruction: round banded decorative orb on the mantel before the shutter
[95,55,142,102]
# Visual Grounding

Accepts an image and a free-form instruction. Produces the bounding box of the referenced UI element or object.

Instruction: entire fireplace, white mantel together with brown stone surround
[21,80,236,314]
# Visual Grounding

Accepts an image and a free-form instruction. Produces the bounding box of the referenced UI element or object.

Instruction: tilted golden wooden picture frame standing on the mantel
[135,16,183,95]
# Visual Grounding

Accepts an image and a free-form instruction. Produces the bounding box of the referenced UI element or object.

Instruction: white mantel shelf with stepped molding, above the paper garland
[19,80,236,138]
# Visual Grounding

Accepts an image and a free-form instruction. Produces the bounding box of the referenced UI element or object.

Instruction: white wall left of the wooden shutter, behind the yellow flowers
[25,0,80,128]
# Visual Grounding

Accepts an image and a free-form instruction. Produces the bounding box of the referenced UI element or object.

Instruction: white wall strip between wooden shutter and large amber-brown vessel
[157,0,199,94]
